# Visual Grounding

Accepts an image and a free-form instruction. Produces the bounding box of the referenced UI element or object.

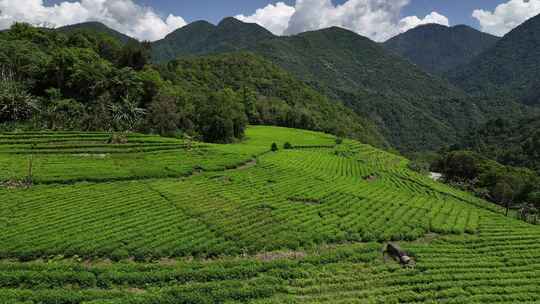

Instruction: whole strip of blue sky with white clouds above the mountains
[11,0,540,41]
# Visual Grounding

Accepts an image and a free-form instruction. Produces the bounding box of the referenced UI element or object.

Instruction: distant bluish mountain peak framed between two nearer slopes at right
[383,24,500,74]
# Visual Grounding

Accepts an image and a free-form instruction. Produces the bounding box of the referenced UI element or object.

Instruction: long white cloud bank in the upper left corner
[0,0,186,41]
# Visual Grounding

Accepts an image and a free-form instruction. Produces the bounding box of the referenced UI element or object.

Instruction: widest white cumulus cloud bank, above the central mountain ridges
[236,0,449,41]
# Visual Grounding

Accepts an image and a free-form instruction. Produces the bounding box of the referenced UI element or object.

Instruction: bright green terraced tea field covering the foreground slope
[0,127,540,304]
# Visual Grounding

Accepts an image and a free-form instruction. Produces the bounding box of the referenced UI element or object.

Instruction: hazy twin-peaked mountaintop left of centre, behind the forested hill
[152,18,274,62]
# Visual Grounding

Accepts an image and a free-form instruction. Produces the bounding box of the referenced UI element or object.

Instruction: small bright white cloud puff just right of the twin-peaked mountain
[235,2,295,35]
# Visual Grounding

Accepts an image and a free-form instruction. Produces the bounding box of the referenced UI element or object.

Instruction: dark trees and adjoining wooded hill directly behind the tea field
[0,23,385,146]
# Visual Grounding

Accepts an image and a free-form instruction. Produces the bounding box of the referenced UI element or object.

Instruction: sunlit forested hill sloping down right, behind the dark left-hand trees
[160,52,386,147]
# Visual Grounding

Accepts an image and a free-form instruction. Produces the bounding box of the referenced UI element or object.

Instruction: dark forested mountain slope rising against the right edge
[449,15,540,105]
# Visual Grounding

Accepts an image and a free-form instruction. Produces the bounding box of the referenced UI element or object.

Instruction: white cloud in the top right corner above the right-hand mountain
[472,0,540,36]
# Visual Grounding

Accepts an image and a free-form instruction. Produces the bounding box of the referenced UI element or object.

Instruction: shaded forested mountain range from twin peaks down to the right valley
[153,18,521,151]
